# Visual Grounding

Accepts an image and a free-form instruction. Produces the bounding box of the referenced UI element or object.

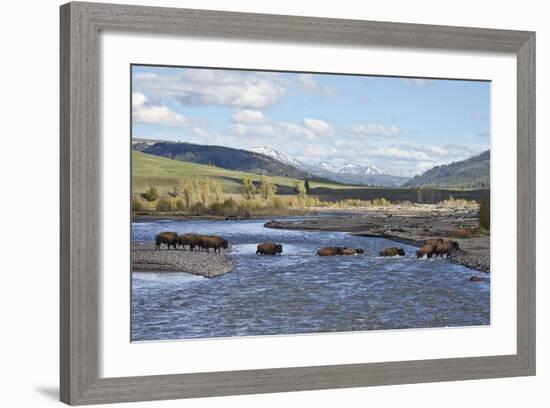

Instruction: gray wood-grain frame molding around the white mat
[60,3,535,405]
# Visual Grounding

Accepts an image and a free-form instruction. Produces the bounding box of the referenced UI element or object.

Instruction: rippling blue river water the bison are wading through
[132,220,490,341]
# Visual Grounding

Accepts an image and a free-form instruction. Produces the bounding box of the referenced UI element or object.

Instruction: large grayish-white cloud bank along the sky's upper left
[134,69,286,109]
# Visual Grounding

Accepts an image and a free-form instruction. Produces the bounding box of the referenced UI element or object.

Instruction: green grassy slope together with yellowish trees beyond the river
[132,151,488,218]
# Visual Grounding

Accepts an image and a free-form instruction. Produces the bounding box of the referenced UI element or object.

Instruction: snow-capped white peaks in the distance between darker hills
[251,146,413,186]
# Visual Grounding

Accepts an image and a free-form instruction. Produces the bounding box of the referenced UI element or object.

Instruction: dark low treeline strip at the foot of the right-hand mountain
[309,187,490,204]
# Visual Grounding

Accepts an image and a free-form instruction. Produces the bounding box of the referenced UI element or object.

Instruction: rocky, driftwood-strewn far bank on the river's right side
[265,205,491,273]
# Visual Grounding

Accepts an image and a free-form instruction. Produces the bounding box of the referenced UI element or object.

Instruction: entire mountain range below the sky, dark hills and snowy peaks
[132,139,490,189]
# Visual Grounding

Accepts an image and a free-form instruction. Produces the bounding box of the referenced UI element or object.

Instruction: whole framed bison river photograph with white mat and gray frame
[60,3,535,405]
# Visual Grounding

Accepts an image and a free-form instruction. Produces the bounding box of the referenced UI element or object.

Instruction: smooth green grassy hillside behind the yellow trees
[132,151,356,194]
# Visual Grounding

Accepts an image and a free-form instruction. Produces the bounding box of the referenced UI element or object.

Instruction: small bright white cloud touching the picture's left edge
[132,92,188,127]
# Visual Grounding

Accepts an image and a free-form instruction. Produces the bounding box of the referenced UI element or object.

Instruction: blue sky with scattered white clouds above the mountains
[132,65,490,174]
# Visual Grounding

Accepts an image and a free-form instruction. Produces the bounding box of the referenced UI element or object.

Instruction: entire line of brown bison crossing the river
[155,231,459,258]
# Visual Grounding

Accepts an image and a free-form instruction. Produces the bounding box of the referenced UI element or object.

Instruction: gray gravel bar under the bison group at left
[131,242,234,278]
